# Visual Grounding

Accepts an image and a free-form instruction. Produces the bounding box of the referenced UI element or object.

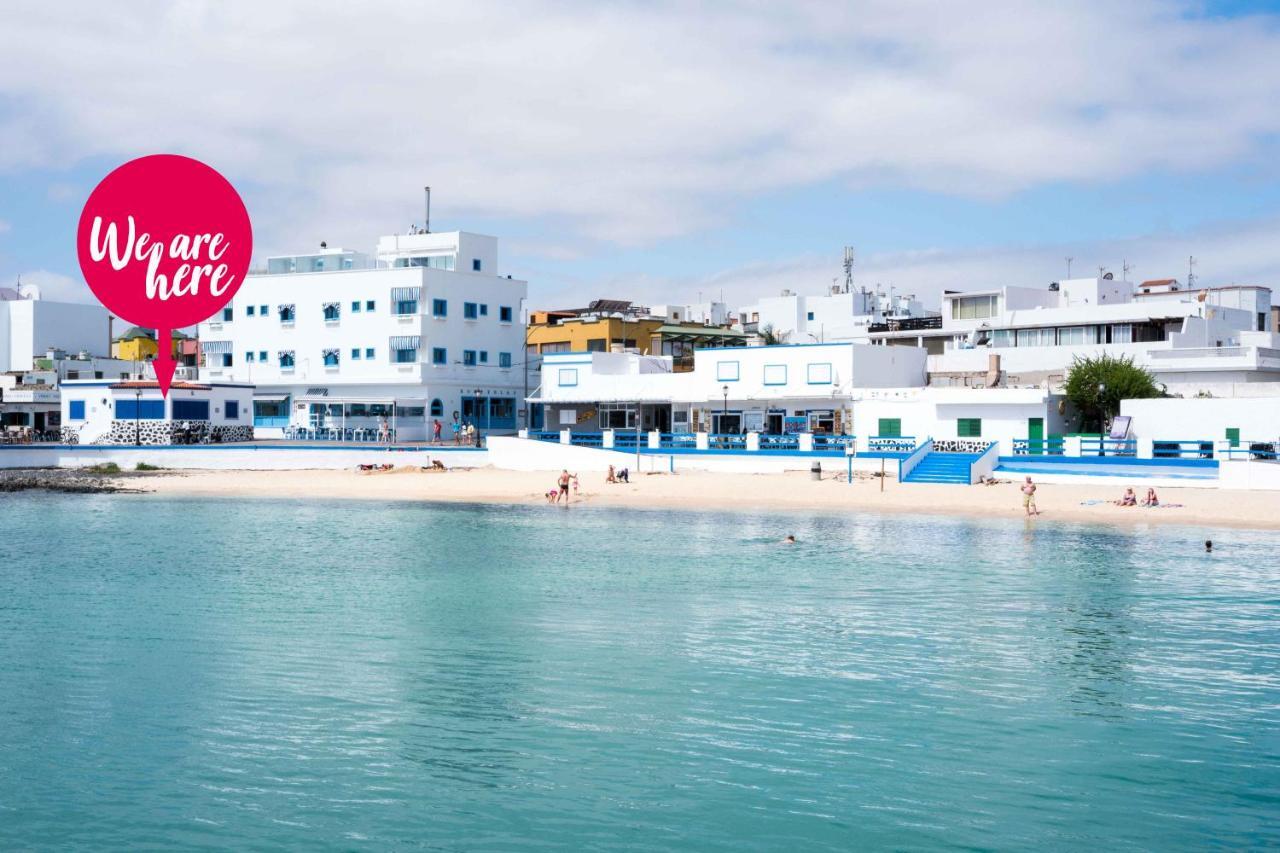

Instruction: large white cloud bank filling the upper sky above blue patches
[0,0,1280,251]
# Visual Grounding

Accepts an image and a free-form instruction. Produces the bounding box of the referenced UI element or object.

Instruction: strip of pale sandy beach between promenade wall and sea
[110,467,1280,529]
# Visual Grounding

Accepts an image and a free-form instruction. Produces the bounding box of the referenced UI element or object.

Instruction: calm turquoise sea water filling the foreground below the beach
[0,494,1280,850]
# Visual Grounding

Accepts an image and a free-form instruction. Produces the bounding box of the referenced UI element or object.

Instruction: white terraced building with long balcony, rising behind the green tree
[872,278,1280,394]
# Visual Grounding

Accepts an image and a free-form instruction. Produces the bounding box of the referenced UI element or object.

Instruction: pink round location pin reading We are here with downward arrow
[76,154,253,397]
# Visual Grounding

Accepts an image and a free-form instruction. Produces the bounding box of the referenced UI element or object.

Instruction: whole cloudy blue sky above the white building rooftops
[0,0,1280,307]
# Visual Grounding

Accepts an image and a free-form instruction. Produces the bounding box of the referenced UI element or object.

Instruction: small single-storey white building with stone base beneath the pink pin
[61,379,253,444]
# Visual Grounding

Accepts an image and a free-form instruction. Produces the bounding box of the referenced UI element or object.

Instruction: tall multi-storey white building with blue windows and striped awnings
[200,232,527,441]
